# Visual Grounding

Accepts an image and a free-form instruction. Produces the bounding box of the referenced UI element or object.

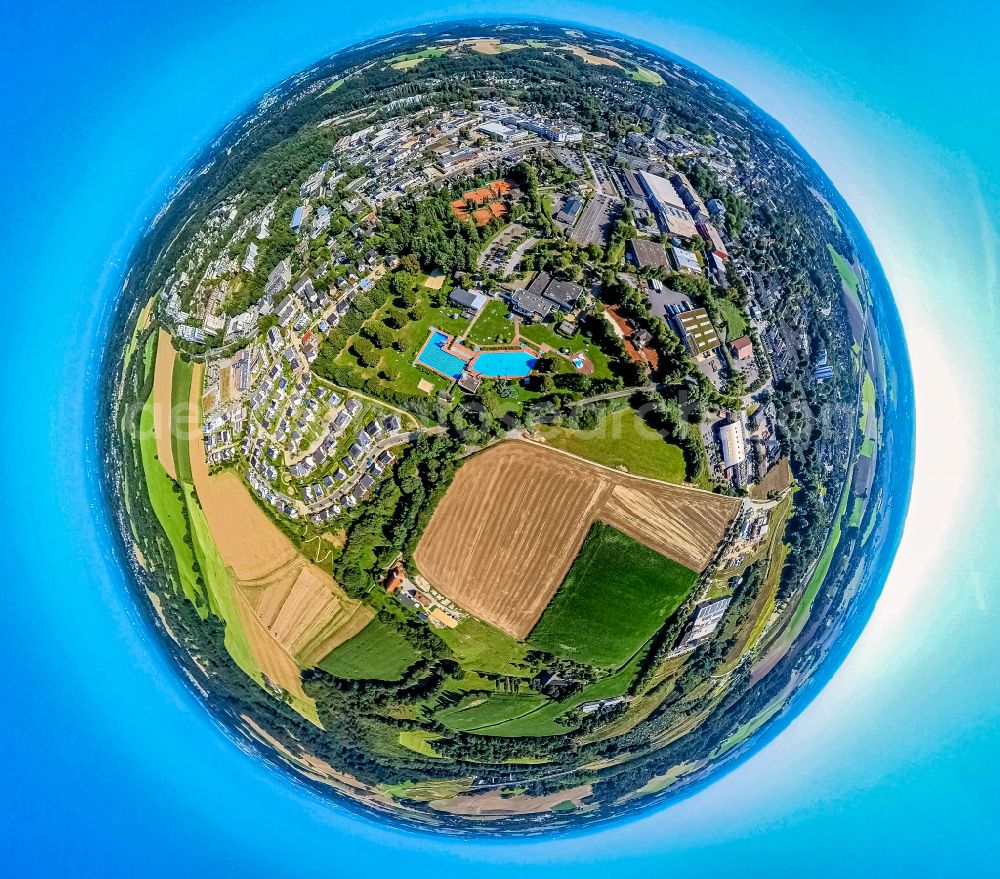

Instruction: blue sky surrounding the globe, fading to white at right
[0,0,1000,877]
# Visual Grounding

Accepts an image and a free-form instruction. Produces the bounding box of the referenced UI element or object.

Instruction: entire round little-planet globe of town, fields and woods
[103,21,901,834]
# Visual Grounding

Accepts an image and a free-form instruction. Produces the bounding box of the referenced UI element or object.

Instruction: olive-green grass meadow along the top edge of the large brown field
[541,409,687,483]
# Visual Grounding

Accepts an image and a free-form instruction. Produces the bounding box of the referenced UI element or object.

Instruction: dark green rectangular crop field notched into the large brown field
[528,522,698,668]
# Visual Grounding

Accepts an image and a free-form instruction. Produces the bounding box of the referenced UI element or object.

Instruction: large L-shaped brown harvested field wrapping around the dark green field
[414,440,739,639]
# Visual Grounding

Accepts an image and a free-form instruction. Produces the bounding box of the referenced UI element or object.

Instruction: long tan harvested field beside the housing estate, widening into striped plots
[190,364,374,704]
